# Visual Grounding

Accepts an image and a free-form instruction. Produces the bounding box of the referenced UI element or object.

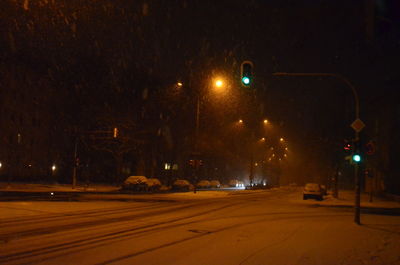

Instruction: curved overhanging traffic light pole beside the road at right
[272,72,361,224]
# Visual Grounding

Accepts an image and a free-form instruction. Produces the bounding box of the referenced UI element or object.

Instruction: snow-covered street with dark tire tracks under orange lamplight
[0,188,400,265]
